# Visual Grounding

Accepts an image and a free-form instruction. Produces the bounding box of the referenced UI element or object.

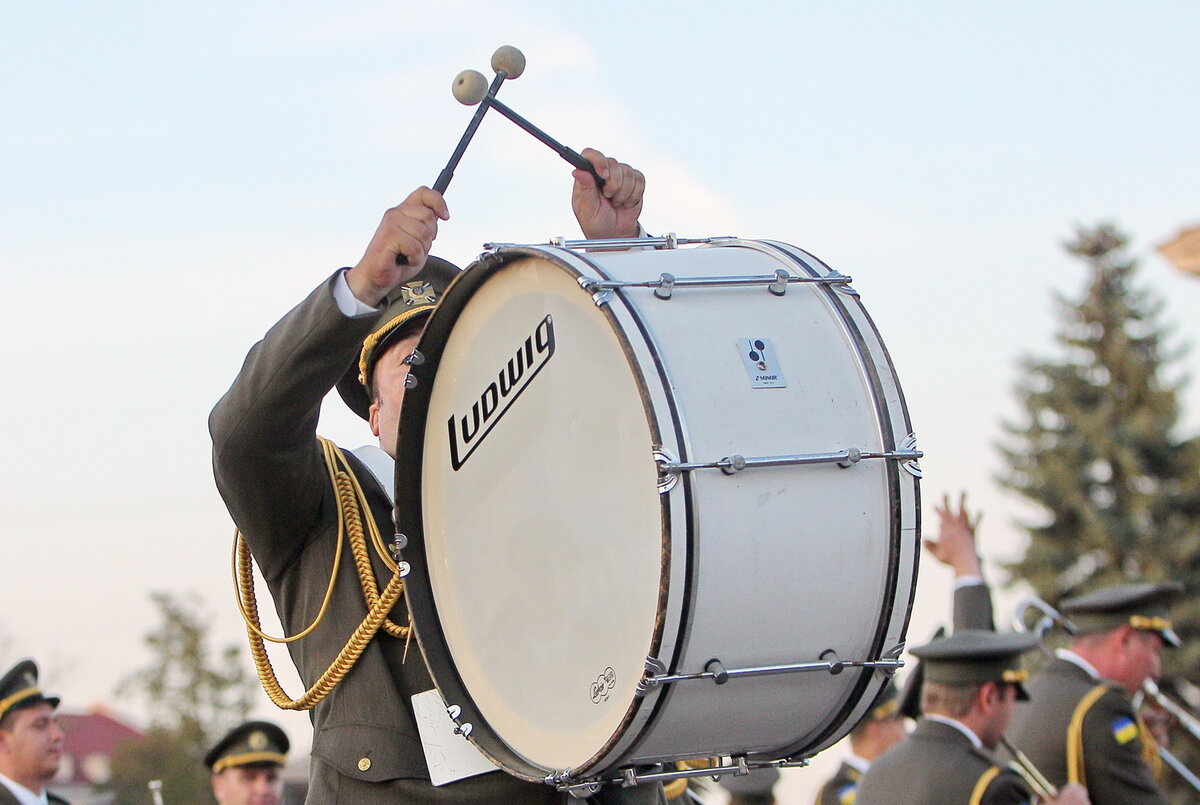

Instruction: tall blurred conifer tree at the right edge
[1001,224,1200,801]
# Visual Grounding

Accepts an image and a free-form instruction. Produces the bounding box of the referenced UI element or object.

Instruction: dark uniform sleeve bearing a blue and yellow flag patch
[1084,690,1168,805]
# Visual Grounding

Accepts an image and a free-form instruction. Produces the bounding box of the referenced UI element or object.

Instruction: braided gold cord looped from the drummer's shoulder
[233,437,409,710]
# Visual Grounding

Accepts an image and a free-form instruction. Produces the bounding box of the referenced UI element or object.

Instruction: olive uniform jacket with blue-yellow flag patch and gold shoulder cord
[1007,657,1166,805]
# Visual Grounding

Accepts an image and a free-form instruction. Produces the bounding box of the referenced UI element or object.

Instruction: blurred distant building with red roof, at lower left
[50,705,144,805]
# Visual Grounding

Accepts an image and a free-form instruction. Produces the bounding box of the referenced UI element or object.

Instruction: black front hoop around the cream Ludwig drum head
[395,246,676,782]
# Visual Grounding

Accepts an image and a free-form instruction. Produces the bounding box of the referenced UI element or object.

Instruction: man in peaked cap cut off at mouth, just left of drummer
[204,721,289,805]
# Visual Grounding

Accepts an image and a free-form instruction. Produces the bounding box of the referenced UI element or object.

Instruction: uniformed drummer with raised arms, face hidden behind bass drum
[209,149,662,805]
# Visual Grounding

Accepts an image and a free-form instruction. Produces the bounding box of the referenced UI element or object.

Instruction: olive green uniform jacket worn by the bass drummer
[209,275,662,805]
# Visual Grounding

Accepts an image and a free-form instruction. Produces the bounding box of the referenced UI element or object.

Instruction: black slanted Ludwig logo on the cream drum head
[446,316,554,471]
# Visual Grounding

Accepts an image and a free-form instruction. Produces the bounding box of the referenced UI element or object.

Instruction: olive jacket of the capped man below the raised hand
[854,719,1032,805]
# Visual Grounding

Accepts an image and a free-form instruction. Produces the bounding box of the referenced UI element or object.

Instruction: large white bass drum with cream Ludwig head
[396,239,920,787]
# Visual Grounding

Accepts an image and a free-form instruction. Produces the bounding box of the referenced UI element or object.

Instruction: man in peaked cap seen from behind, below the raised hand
[854,630,1087,805]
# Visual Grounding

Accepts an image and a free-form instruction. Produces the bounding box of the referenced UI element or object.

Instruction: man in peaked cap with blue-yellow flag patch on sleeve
[1010,584,1183,805]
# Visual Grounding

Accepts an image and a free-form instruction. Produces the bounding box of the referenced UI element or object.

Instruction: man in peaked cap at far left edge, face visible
[0,660,67,805]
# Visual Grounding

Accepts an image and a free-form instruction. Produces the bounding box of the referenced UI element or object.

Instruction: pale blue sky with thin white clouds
[0,0,1200,805]
